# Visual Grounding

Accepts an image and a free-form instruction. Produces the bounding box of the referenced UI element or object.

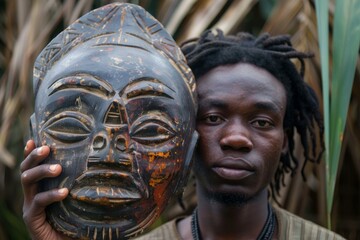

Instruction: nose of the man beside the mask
[220,119,253,152]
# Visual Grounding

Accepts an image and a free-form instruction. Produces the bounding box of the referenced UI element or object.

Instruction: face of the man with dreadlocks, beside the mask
[195,63,287,204]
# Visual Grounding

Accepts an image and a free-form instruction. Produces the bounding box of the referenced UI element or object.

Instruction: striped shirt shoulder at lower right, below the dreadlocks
[274,207,345,240]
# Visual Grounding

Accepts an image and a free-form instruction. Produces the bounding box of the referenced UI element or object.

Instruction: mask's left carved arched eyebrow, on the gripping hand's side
[48,73,115,97]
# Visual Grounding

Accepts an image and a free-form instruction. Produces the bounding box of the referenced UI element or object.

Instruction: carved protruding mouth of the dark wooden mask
[70,169,148,206]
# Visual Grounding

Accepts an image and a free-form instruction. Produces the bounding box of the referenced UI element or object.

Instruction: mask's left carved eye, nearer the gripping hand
[44,112,91,143]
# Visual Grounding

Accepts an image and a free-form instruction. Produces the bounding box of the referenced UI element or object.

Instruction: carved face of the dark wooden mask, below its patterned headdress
[35,44,195,236]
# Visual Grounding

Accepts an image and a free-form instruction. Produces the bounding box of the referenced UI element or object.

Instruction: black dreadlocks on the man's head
[182,30,324,198]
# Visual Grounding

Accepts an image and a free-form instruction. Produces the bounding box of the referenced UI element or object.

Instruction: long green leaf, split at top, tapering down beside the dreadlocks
[315,0,360,228]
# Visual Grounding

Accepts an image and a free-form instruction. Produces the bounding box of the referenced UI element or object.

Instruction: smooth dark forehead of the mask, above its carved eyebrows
[40,45,187,96]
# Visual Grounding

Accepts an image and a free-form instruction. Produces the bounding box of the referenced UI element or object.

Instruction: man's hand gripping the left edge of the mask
[20,140,69,240]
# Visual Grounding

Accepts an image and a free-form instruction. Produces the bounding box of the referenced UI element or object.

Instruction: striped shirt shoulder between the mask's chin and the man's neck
[135,218,181,240]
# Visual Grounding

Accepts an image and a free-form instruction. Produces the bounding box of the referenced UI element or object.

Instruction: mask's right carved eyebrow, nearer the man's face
[121,78,176,100]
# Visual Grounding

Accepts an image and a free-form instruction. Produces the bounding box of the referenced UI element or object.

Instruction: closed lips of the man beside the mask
[212,158,255,181]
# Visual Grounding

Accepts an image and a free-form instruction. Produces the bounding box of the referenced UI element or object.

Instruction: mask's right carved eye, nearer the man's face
[132,120,175,146]
